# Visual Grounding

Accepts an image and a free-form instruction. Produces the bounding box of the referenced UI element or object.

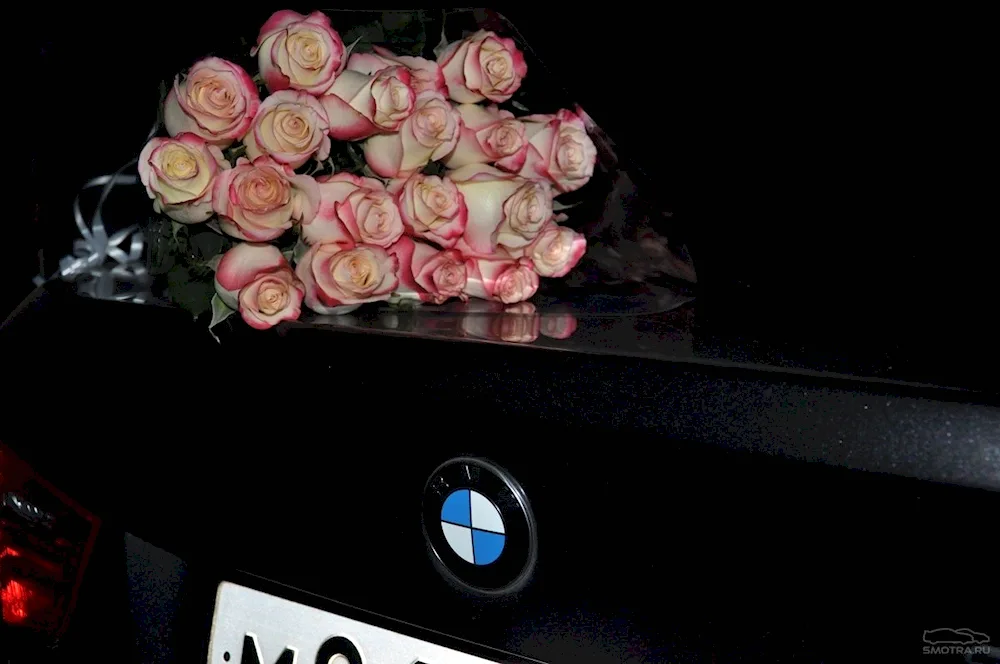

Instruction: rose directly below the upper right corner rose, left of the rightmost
[444,104,528,173]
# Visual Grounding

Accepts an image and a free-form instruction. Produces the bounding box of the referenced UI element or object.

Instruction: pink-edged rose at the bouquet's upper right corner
[438,30,528,104]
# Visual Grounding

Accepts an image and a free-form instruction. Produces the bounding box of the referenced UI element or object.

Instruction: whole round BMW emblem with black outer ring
[423,457,538,595]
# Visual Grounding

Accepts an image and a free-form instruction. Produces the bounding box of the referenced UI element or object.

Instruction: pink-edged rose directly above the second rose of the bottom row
[302,173,403,248]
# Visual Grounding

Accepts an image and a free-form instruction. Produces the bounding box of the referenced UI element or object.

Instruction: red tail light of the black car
[0,445,99,637]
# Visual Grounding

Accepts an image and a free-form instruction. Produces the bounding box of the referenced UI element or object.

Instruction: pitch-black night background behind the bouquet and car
[13,5,997,382]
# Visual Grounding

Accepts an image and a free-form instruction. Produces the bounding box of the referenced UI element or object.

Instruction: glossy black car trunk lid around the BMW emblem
[0,294,1000,664]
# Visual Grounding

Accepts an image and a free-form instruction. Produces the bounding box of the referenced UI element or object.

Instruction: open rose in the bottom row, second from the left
[295,241,399,314]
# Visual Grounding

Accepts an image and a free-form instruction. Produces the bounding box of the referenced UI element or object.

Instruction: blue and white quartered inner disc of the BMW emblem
[441,489,507,565]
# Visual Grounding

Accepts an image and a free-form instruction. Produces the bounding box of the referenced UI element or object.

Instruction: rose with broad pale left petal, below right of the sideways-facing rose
[364,92,462,178]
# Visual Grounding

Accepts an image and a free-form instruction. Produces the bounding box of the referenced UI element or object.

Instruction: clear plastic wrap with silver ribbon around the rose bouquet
[54,9,696,354]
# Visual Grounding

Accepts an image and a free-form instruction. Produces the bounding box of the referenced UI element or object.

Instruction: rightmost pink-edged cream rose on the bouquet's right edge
[520,109,597,192]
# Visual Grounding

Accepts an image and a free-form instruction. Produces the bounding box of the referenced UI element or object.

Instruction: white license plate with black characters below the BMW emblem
[208,582,508,664]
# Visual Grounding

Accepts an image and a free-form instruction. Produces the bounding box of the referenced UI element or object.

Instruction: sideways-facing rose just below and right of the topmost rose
[319,67,416,141]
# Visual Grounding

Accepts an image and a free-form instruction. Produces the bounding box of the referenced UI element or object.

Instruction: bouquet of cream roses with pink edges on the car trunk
[139,10,597,329]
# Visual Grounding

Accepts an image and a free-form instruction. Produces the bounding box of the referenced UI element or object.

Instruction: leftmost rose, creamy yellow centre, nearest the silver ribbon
[139,132,229,224]
